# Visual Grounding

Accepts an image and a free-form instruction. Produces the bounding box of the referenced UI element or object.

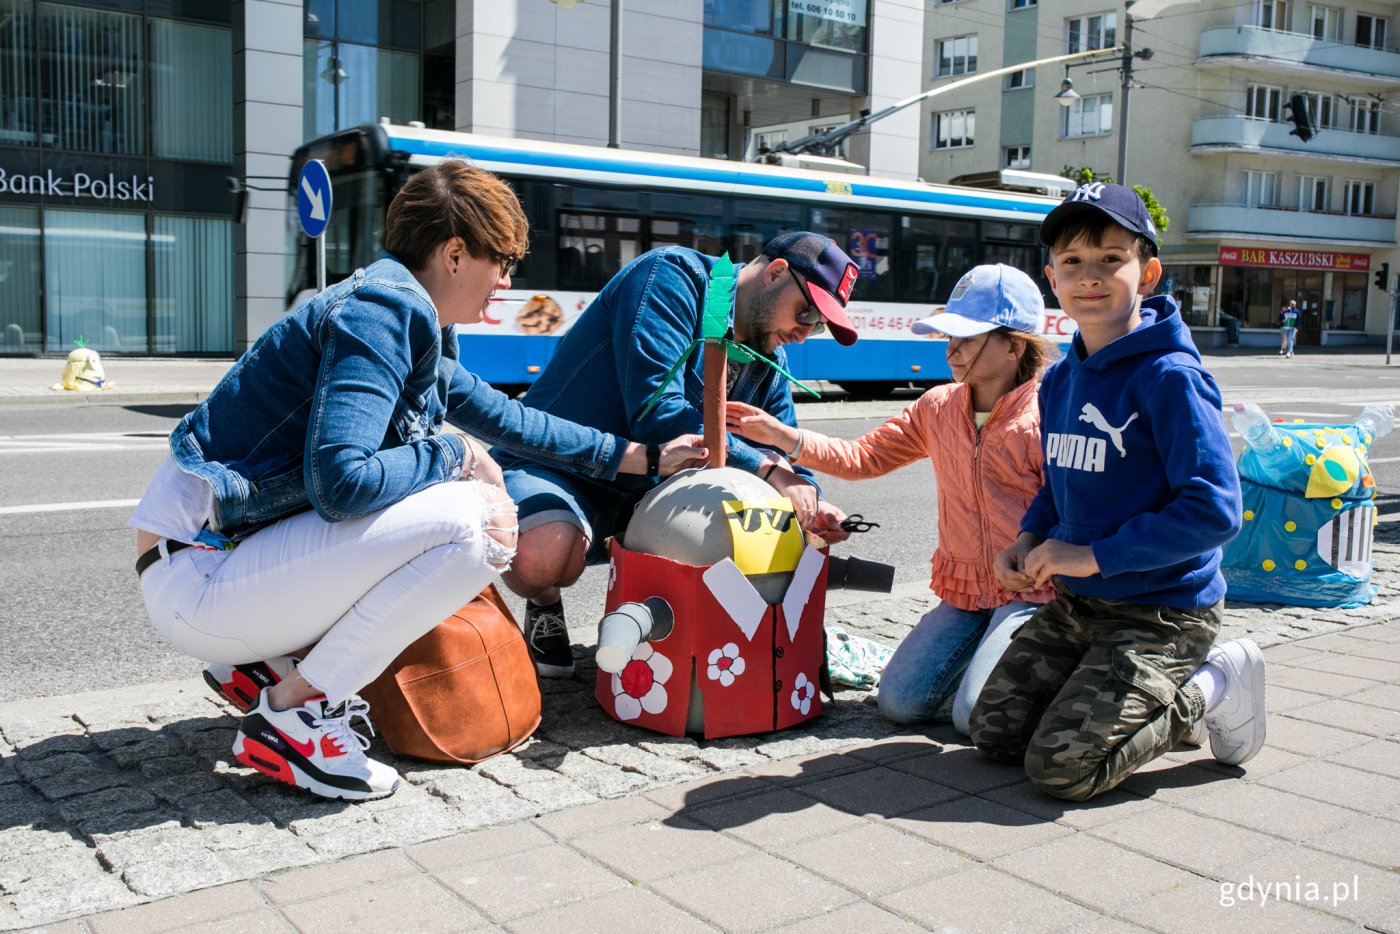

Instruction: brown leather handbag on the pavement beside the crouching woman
[360,585,540,765]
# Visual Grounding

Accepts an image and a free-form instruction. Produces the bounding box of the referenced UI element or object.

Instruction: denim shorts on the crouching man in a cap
[501,462,643,564]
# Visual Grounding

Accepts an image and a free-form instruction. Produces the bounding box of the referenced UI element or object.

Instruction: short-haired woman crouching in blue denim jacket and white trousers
[130,161,704,798]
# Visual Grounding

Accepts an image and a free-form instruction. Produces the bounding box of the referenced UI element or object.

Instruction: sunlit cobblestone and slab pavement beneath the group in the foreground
[0,525,1400,931]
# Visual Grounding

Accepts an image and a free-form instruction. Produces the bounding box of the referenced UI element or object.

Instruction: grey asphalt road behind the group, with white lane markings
[0,356,1400,702]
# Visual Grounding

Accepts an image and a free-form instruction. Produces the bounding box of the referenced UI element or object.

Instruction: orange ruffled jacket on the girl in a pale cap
[799,379,1054,609]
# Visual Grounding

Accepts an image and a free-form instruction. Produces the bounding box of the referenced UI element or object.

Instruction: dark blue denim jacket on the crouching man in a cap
[503,246,815,490]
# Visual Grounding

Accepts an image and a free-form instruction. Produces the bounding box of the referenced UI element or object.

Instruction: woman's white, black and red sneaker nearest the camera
[234,690,399,800]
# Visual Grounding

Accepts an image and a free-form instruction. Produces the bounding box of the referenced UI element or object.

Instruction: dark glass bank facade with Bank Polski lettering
[0,0,234,354]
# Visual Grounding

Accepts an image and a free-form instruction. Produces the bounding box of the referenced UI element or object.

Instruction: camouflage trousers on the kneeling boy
[970,587,1224,801]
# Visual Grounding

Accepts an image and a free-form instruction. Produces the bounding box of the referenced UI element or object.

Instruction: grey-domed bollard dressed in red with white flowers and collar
[596,468,827,739]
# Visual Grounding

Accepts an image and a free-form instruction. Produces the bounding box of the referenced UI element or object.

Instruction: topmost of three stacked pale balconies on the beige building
[1196,27,1400,90]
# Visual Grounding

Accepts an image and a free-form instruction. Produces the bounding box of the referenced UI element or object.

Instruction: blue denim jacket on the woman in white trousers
[171,253,626,539]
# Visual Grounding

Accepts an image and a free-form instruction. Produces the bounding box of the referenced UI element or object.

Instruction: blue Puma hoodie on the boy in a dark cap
[1021,295,1240,609]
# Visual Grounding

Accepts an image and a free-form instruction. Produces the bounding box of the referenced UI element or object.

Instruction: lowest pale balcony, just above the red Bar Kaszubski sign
[1186,204,1396,246]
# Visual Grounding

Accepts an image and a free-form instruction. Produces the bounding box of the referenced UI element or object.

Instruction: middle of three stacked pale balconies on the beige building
[1191,115,1400,167]
